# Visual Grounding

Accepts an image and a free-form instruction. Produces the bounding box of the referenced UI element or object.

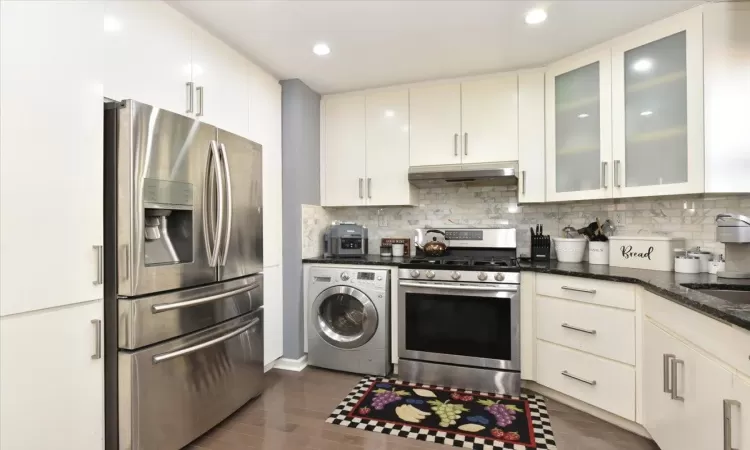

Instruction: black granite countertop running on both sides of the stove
[302,255,750,331]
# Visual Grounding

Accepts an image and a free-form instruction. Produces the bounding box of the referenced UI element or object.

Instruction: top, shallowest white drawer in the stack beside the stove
[536,275,635,311]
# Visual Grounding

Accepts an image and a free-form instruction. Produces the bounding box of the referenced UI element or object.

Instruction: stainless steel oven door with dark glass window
[398,280,521,370]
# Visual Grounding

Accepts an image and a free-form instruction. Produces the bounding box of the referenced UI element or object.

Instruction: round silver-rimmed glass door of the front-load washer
[312,286,378,349]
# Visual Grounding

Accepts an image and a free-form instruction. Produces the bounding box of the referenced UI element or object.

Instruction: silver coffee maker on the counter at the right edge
[716,214,750,278]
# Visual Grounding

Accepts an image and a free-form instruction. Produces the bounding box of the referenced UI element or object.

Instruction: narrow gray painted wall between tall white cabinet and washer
[281,79,320,359]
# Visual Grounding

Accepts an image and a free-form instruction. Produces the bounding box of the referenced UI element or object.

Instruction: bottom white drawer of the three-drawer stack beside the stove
[536,340,635,421]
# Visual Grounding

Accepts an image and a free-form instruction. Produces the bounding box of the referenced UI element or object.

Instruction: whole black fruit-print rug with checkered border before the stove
[326,376,557,450]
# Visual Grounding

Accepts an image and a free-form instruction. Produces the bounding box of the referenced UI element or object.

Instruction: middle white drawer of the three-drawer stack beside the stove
[537,296,635,365]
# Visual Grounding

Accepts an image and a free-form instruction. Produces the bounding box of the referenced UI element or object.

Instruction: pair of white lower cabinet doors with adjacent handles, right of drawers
[643,320,732,450]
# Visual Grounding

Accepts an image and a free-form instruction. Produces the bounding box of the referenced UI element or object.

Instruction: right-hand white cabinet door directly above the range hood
[461,74,518,164]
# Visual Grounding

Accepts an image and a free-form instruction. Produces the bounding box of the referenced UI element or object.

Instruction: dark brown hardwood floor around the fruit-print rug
[186,367,658,450]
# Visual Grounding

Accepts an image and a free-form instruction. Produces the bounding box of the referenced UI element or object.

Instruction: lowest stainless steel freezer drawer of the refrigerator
[118,308,264,450]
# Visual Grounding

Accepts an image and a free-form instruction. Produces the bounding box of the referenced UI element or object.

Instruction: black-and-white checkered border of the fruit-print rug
[326,376,557,450]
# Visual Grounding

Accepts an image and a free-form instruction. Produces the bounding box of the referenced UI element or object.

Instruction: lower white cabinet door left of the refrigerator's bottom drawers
[0,301,104,450]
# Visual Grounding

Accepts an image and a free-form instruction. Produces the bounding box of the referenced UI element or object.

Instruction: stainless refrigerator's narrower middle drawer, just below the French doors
[117,273,263,350]
